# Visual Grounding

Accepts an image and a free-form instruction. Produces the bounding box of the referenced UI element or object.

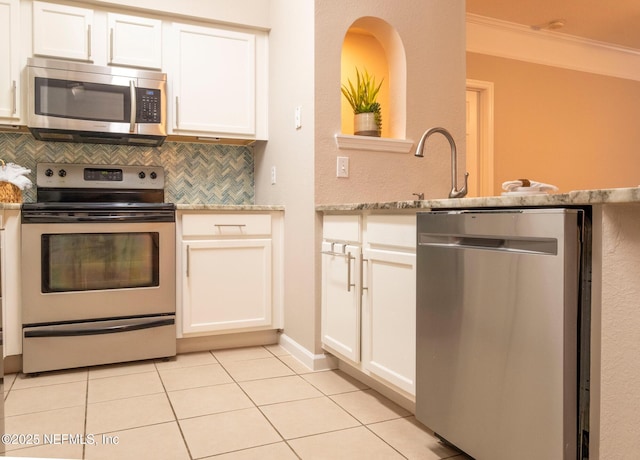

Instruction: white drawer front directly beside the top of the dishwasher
[367,214,416,249]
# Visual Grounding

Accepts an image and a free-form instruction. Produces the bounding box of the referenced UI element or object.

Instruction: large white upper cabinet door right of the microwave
[173,24,256,136]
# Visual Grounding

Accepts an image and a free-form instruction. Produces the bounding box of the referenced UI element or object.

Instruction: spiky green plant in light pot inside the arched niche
[342,68,384,137]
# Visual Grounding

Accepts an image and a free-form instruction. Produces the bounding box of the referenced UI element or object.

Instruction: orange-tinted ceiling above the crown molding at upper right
[466,0,640,50]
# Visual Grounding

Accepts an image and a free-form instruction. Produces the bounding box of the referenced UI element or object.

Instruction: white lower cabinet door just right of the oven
[182,239,272,333]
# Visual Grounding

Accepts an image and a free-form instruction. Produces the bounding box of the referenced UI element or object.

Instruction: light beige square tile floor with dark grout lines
[5,345,467,460]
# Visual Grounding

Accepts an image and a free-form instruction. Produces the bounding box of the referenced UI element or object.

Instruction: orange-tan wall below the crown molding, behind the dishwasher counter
[467,53,640,194]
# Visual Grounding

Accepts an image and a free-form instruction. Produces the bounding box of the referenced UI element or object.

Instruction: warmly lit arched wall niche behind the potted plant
[340,16,407,139]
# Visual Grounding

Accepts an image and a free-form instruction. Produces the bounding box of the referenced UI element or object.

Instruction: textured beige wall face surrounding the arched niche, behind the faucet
[315,0,465,204]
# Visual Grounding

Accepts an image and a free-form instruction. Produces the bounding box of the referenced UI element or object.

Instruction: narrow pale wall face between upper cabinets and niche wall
[255,0,316,352]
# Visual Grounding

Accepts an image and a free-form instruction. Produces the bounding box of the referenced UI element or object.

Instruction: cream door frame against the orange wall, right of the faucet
[466,79,496,196]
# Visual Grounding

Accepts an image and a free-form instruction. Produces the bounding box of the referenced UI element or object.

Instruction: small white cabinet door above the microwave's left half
[33,1,93,62]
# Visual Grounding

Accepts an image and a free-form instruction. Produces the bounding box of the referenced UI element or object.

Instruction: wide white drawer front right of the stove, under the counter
[182,214,271,236]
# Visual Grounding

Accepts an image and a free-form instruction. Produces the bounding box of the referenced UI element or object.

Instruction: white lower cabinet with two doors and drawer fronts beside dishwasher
[321,214,416,395]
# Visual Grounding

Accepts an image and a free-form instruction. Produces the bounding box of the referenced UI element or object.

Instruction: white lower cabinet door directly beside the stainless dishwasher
[362,249,416,395]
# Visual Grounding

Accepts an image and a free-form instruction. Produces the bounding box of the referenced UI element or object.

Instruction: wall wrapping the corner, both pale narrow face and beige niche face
[255,0,465,354]
